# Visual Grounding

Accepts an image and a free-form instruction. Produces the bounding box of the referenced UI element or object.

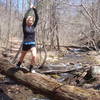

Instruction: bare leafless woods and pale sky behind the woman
[0,0,100,49]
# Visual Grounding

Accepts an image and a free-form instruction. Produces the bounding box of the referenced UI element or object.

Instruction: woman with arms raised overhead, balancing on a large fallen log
[16,4,39,73]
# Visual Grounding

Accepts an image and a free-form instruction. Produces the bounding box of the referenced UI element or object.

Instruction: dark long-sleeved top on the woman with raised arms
[22,8,39,42]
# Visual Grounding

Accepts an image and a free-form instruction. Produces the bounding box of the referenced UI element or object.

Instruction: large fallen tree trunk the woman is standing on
[0,59,100,100]
